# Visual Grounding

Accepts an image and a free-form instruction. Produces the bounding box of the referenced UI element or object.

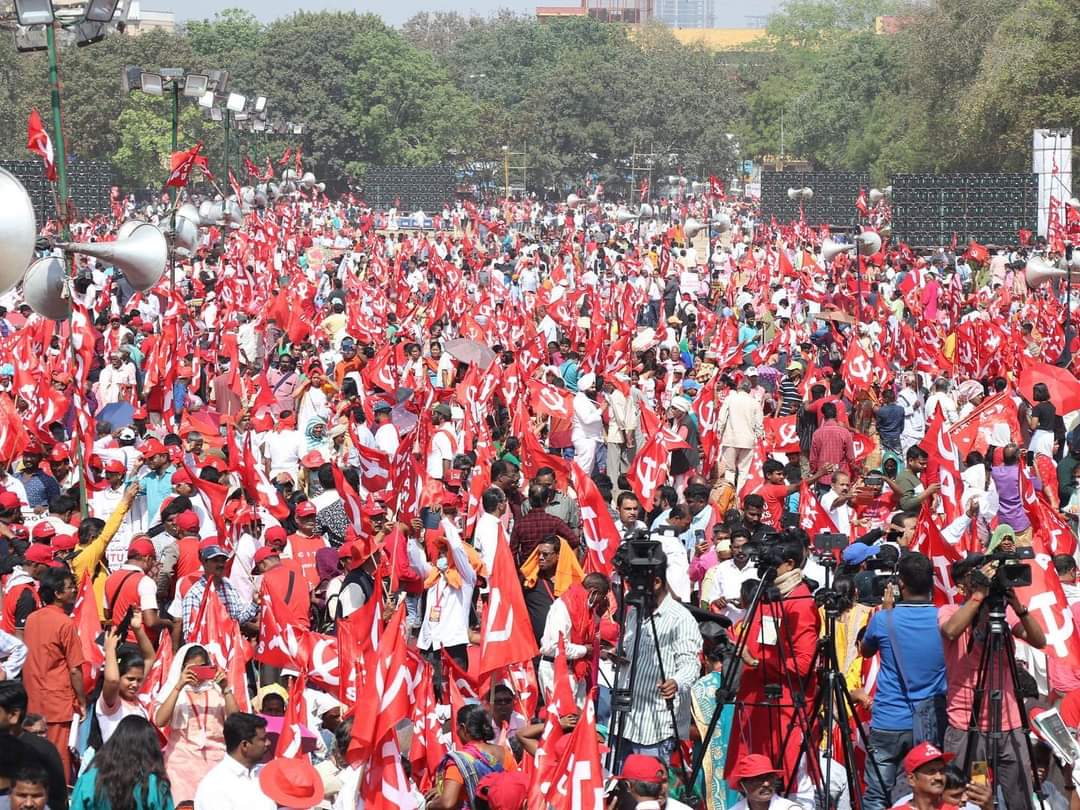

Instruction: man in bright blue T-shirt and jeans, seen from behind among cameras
[861,552,946,810]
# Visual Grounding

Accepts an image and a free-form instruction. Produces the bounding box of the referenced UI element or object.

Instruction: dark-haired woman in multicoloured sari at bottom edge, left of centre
[424,704,517,810]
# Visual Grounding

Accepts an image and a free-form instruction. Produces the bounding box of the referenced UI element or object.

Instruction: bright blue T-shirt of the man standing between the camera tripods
[863,603,946,731]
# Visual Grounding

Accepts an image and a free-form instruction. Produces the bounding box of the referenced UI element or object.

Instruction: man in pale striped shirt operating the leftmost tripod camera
[613,548,704,772]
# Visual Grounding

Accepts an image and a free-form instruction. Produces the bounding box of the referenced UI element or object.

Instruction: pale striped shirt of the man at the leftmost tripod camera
[619,596,702,745]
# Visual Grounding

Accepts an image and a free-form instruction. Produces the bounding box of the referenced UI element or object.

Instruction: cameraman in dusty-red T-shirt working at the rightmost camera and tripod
[937,554,1047,810]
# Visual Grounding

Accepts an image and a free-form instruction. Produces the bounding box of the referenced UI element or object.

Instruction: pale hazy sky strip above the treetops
[164,0,780,28]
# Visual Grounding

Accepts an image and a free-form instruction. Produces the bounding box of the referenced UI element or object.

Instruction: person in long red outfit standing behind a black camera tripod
[726,528,820,804]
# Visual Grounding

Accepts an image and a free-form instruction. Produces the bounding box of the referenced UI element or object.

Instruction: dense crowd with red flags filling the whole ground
[0,182,1080,810]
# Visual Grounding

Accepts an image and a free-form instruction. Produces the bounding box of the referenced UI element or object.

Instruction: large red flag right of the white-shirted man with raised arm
[480,529,539,675]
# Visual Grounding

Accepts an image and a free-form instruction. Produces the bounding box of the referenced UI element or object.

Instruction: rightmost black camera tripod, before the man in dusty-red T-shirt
[963,585,1047,810]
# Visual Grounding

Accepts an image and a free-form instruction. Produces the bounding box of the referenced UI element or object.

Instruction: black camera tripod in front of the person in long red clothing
[687,567,829,810]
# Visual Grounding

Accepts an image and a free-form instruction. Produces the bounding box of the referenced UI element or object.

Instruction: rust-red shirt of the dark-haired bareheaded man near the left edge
[23,605,83,723]
